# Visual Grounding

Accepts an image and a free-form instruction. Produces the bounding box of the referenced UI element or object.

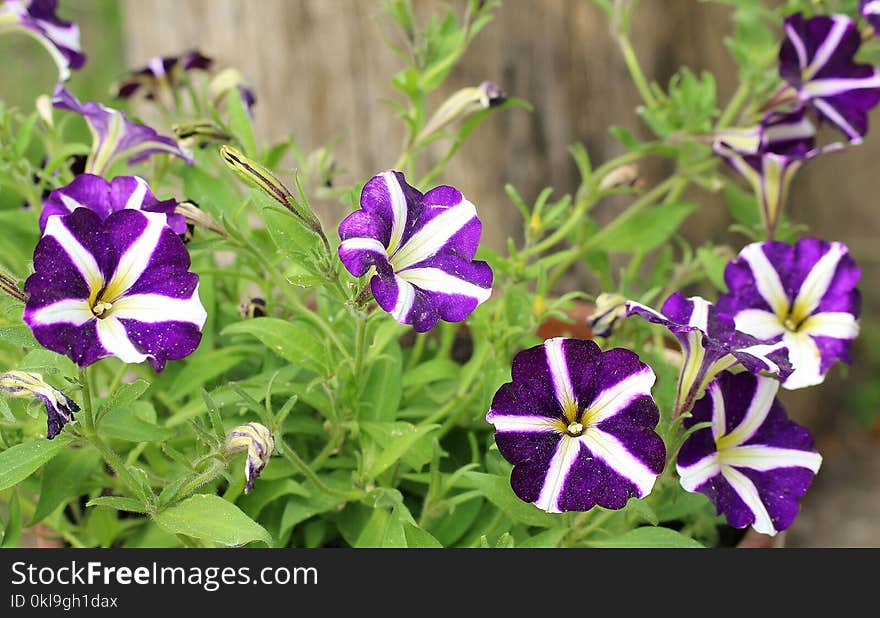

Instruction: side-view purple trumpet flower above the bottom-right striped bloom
[627,292,791,417]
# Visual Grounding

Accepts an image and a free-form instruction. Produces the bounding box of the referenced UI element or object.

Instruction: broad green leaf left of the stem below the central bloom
[220,318,330,375]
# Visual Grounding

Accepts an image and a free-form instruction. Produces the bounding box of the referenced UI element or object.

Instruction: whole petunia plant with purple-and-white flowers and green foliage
[0,0,880,547]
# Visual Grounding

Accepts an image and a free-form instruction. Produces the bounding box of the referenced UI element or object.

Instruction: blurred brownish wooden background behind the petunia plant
[0,0,880,546]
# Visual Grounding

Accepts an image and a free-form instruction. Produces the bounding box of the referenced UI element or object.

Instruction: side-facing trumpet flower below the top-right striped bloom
[713,107,843,237]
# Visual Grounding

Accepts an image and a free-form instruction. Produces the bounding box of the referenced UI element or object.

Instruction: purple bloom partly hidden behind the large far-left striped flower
[40,174,186,234]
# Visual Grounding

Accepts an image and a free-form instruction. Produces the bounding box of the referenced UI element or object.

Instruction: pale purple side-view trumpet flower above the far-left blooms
[52,85,193,175]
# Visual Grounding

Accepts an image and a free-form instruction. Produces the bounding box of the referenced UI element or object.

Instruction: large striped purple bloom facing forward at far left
[23,208,207,371]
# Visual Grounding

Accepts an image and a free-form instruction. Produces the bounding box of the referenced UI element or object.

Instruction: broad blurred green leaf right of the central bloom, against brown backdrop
[591,202,696,253]
